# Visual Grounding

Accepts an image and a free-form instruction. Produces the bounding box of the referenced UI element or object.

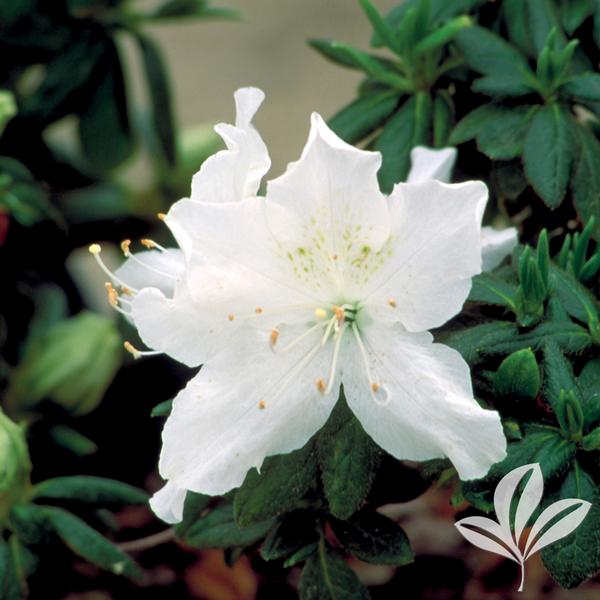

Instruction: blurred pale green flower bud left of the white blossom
[6,312,123,415]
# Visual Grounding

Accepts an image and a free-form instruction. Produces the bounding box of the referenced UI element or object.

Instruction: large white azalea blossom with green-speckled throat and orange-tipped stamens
[91,88,506,522]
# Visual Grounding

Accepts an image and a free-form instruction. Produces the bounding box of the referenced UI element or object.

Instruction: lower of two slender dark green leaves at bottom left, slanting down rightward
[43,506,142,579]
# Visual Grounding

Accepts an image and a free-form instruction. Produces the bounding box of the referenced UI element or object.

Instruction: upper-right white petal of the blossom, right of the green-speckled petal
[363,180,487,331]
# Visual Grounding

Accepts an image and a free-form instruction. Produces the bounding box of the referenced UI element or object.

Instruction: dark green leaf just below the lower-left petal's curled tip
[183,503,274,548]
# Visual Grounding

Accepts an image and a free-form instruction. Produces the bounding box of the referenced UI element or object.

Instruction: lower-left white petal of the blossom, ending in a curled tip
[151,328,339,518]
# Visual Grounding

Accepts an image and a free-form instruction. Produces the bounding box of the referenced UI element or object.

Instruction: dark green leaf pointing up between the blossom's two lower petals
[317,393,381,519]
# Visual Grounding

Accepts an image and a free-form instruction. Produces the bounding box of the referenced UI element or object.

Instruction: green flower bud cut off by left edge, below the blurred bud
[0,410,31,525]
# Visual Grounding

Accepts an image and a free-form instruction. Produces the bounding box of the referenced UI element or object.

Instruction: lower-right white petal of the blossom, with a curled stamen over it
[342,326,506,479]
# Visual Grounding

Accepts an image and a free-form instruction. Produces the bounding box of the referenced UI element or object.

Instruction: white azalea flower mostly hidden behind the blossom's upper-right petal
[407,146,518,271]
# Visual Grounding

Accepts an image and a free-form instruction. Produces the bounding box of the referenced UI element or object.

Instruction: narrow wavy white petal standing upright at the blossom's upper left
[192,88,271,202]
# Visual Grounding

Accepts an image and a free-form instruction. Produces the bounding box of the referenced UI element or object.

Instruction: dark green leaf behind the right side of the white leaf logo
[542,463,600,589]
